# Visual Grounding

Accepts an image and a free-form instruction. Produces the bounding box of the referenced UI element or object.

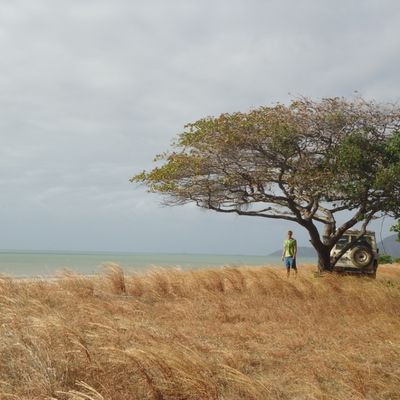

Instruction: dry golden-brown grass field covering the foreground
[0,265,400,400]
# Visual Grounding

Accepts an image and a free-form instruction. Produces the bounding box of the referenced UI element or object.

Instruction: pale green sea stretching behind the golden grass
[0,250,315,277]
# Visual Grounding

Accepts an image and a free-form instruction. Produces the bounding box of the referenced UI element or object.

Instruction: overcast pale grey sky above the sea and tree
[0,0,400,255]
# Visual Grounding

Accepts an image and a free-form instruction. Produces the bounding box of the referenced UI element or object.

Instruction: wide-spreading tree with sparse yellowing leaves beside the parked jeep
[131,98,400,270]
